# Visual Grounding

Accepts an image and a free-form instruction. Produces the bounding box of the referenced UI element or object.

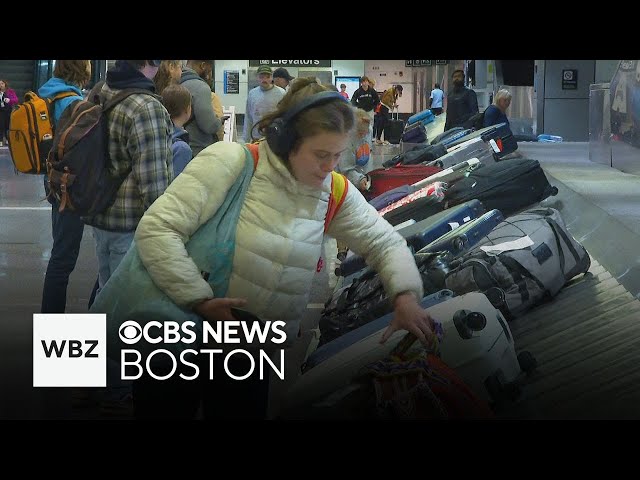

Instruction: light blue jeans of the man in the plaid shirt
[93,228,135,400]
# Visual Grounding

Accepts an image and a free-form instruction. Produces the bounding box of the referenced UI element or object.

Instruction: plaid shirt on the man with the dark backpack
[83,85,173,232]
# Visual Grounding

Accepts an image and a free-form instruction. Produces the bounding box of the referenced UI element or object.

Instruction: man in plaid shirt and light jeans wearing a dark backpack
[83,60,173,296]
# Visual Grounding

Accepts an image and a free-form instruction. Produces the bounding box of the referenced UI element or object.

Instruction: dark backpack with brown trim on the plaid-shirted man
[47,88,156,216]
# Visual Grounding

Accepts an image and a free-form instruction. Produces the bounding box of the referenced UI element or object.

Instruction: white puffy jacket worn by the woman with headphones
[135,142,423,345]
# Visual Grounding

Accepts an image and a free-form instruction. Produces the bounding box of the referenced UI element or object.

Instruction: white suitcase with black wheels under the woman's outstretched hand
[286,292,536,408]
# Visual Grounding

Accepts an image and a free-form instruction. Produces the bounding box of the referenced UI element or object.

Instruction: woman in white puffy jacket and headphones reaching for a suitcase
[134,78,433,418]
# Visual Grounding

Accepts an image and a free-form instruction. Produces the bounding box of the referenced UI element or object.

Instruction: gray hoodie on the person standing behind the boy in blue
[180,67,222,157]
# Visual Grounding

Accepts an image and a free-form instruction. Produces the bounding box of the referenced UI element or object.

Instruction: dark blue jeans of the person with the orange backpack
[40,204,84,313]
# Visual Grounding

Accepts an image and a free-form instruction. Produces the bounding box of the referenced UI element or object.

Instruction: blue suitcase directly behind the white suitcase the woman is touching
[302,290,454,372]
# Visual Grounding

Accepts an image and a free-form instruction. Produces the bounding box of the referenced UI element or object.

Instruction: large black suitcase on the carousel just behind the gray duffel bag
[445,158,558,216]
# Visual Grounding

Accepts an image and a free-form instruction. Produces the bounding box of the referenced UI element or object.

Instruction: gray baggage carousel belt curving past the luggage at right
[324,143,640,419]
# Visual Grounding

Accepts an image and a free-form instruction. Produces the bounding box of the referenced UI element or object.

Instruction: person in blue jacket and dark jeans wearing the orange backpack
[38,60,91,313]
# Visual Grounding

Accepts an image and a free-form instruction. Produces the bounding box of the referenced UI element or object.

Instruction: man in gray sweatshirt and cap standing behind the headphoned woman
[243,65,285,143]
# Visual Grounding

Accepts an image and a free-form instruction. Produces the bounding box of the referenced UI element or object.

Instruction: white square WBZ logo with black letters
[33,313,107,387]
